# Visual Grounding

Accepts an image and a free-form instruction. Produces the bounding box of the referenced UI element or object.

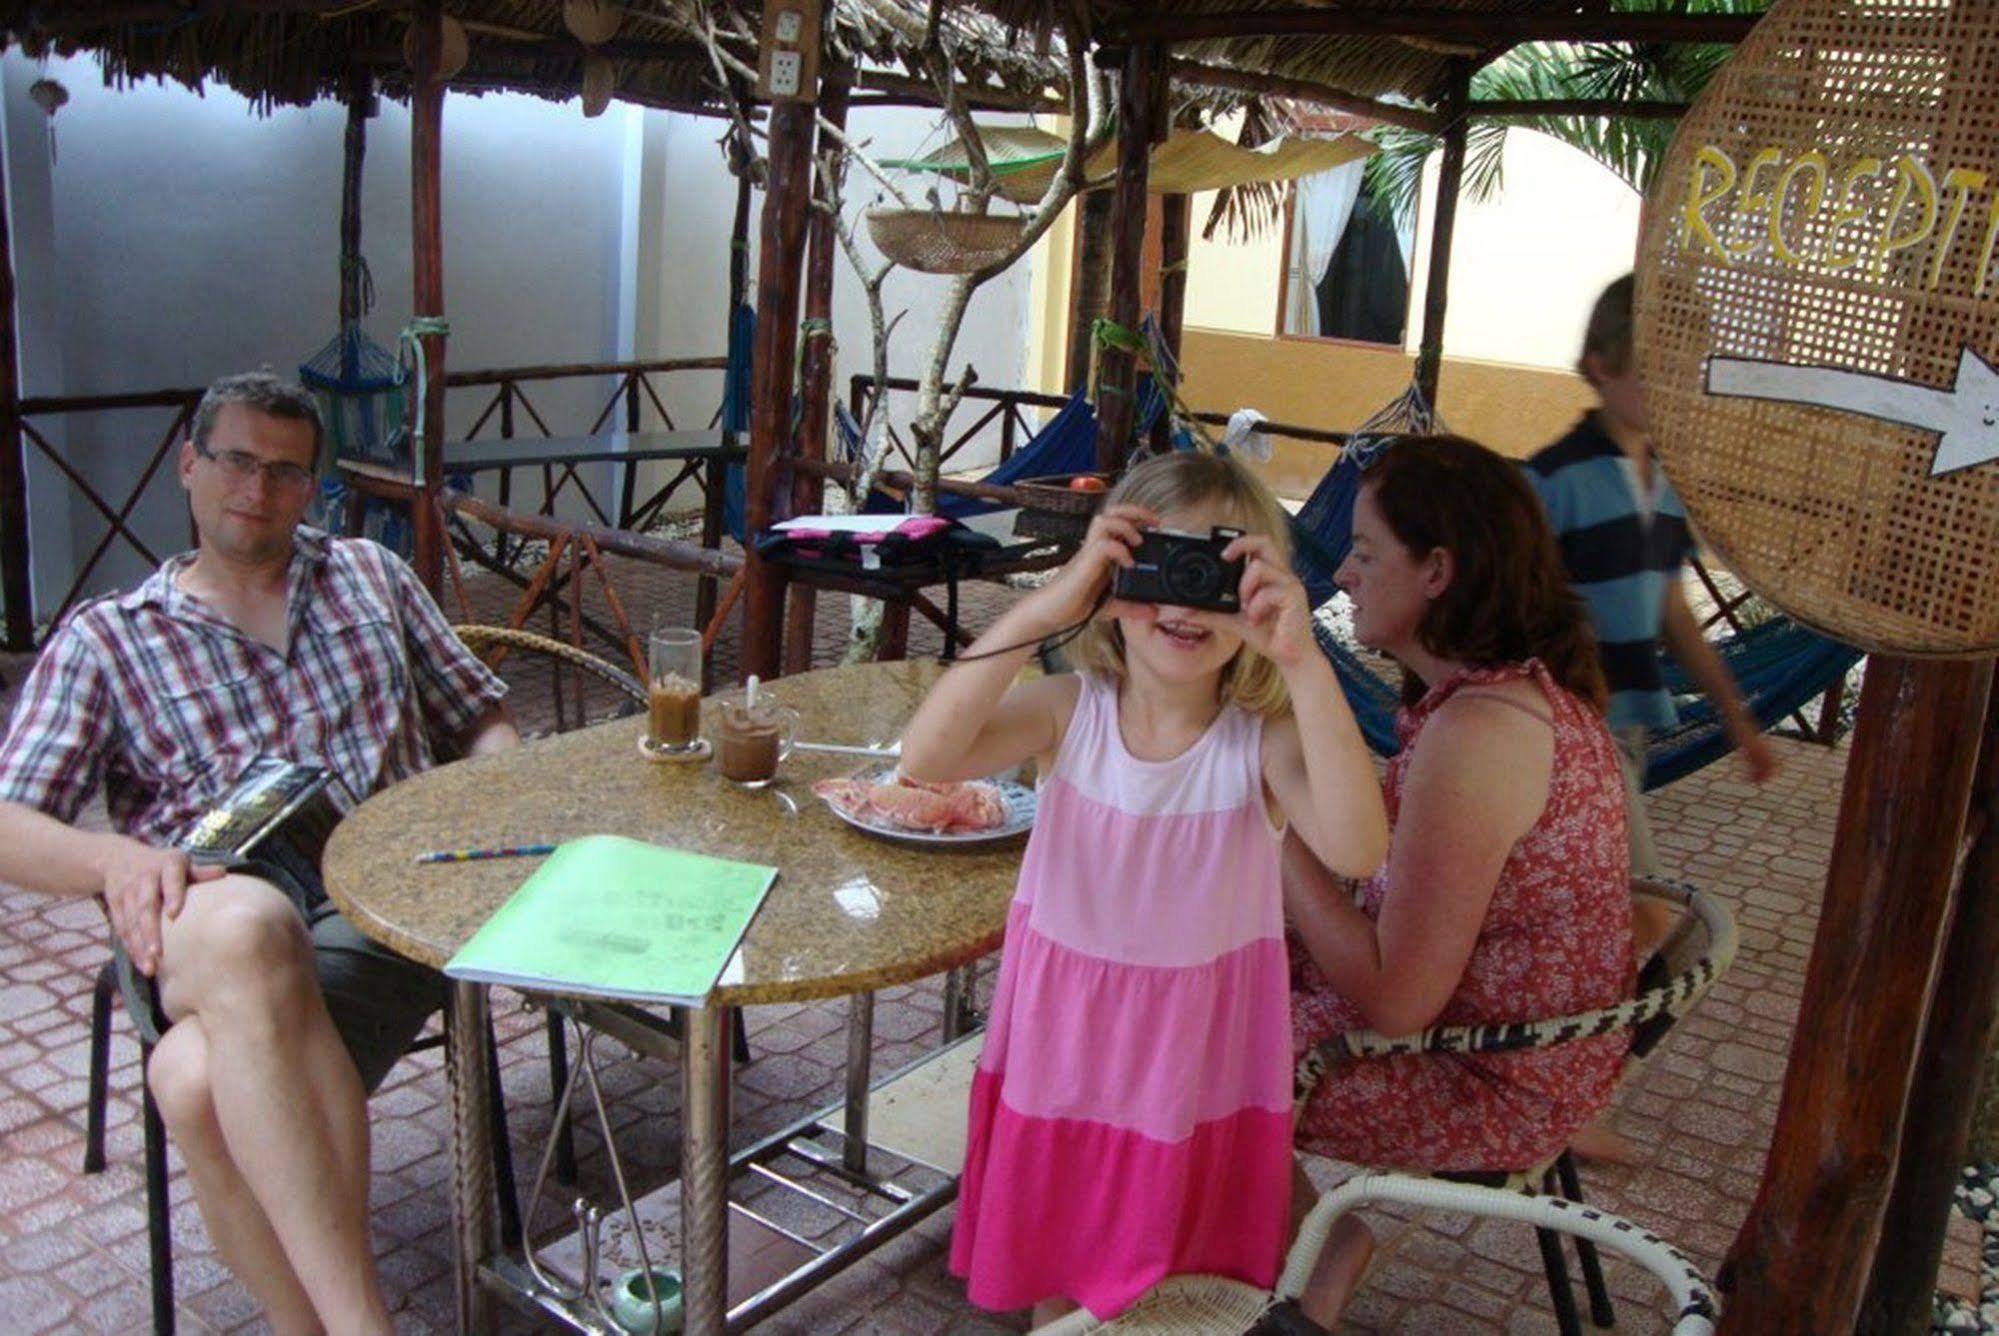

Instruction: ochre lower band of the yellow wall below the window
[1179,328,1595,496]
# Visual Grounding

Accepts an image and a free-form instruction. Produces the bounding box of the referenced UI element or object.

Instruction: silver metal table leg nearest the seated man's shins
[444,982,500,1336]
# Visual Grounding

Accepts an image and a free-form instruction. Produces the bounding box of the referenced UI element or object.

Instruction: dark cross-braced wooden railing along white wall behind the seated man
[0,356,728,650]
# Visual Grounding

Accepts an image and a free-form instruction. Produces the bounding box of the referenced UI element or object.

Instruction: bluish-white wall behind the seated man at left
[4,52,624,616]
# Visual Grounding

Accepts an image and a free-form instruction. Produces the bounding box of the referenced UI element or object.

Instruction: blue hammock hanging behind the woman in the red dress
[1291,438,1861,790]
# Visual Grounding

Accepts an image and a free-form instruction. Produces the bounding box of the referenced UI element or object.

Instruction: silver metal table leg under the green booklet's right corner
[680,1006,736,1336]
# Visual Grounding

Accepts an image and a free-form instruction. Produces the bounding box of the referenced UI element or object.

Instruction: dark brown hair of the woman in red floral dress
[1361,436,1609,712]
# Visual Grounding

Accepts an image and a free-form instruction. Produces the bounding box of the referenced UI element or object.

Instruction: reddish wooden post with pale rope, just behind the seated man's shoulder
[410,0,444,594]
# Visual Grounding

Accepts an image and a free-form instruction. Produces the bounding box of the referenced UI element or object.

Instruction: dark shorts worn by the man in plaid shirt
[112,846,446,1090]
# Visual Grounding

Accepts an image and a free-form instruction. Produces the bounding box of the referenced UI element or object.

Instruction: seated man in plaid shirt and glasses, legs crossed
[0,374,518,1332]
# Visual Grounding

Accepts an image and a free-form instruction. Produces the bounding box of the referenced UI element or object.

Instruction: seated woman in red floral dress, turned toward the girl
[1285,438,1633,1324]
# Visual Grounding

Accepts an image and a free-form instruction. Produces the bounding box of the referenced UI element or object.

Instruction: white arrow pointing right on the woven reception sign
[1707,344,1999,478]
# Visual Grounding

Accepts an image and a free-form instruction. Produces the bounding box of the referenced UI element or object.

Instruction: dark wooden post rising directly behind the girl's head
[1097,42,1165,472]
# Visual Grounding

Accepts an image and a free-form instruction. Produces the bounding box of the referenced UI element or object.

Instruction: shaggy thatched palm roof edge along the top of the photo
[0,0,1759,122]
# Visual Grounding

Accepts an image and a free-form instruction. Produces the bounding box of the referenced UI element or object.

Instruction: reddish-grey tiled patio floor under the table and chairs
[0,548,1969,1334]
